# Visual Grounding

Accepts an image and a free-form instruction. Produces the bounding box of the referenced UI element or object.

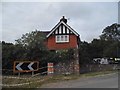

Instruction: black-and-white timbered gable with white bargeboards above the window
[47,21,79,38]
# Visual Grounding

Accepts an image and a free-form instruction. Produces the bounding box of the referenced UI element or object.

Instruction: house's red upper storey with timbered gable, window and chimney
[46,16,80,50]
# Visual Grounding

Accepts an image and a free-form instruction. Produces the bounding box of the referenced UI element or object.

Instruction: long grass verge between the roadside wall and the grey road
[2,71,117,90]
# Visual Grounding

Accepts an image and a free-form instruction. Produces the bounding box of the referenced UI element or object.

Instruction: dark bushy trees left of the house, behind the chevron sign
[2,31,48,74]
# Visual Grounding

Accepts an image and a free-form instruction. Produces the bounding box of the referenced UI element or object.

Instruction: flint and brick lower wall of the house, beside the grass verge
[54,49,80,74]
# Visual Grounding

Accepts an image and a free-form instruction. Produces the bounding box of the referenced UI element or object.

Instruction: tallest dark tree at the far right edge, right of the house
[100,23,120,57]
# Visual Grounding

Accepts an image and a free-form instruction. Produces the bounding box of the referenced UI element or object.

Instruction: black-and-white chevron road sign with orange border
[13,61,39,72]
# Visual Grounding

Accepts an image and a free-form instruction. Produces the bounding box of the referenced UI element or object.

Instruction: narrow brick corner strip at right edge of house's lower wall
[74,48,80,74]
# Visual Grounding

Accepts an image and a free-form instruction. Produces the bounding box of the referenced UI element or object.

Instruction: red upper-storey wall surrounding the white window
[47,35,77,50]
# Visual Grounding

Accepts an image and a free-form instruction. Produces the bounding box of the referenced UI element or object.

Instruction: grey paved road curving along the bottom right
[41,73,118,88]
